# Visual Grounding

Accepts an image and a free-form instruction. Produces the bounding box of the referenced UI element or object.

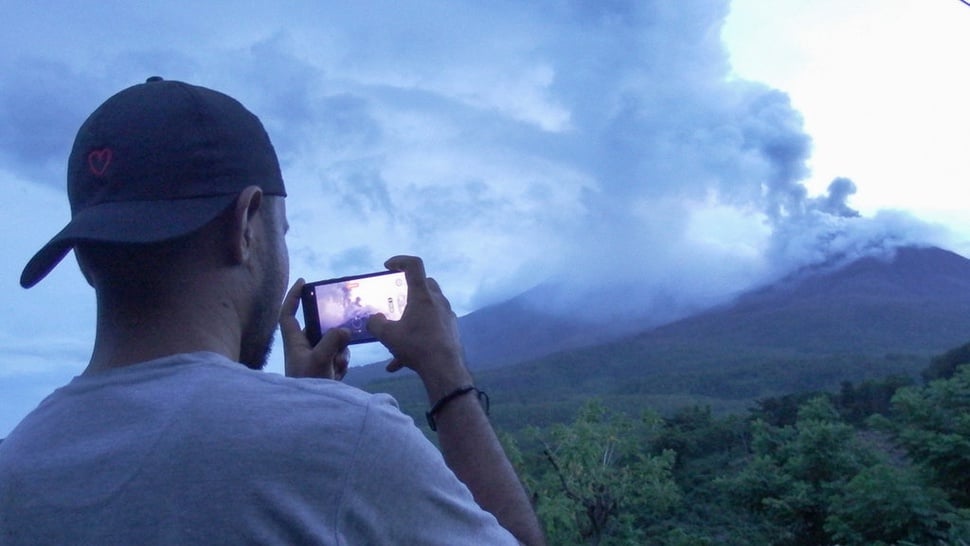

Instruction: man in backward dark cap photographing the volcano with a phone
[0,77,543,544]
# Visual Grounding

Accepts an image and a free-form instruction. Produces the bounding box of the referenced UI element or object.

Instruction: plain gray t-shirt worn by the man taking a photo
[0,353,517,545]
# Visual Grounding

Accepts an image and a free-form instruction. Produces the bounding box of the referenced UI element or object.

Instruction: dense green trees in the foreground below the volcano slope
[504,345,970,546]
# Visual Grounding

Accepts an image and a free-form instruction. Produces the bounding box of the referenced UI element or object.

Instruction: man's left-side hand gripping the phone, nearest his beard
[280,279,350,381]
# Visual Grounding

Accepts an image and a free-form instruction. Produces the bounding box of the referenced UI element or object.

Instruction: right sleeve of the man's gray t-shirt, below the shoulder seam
[338,395,518,545]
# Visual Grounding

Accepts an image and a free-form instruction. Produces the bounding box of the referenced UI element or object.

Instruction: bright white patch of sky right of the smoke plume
[724,0,970,231]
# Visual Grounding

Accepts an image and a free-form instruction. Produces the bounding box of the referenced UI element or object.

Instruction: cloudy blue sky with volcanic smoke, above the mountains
[0,0,970,437]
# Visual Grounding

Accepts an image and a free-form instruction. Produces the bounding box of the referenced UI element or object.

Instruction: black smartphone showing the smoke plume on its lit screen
[300,271,408,345]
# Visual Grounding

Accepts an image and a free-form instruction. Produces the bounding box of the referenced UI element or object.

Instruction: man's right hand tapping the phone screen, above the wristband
[367,256,471,399]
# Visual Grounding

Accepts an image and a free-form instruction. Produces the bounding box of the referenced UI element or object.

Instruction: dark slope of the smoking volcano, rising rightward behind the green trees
[368,244,970,426]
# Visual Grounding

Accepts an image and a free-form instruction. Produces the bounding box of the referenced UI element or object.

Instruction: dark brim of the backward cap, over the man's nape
[20,194,236,288]
